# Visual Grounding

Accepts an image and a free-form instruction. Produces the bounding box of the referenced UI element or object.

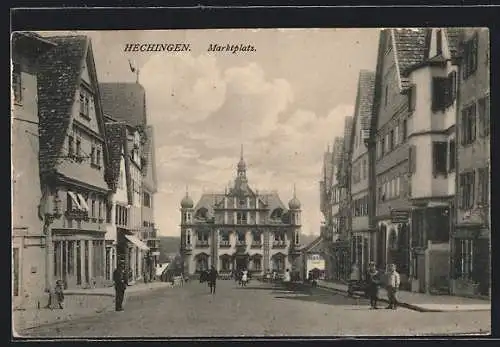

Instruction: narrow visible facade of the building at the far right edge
[451,29,491,296]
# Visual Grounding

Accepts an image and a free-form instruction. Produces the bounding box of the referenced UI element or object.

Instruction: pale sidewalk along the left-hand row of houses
[12,282,172,336]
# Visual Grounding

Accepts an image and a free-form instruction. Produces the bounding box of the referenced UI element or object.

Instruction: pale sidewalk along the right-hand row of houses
[318,281,491,312]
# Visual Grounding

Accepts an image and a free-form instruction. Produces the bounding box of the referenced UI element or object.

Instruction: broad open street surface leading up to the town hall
[17,281,491,337]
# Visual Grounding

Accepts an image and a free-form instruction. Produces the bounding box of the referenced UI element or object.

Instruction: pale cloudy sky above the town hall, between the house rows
[44,29,379,236]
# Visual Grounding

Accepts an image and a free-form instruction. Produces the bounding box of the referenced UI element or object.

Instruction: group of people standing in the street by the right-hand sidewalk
[350,261,401,310]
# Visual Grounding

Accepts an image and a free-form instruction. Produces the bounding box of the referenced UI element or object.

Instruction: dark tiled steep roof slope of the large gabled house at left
[38,36,88,172]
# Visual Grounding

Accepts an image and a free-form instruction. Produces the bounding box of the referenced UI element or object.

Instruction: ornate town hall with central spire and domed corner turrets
[181,153,301,276]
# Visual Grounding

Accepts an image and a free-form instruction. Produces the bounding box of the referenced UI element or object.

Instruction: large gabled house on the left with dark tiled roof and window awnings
[38,36,113,288]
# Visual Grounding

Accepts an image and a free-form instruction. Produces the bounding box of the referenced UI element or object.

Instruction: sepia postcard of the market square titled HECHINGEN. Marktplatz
[11,27,492,339]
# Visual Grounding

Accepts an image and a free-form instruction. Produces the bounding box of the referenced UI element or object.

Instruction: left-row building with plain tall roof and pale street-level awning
[99,82,159,281]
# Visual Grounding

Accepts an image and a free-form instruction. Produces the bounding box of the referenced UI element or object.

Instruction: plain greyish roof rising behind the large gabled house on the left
[99,82,147,127]
